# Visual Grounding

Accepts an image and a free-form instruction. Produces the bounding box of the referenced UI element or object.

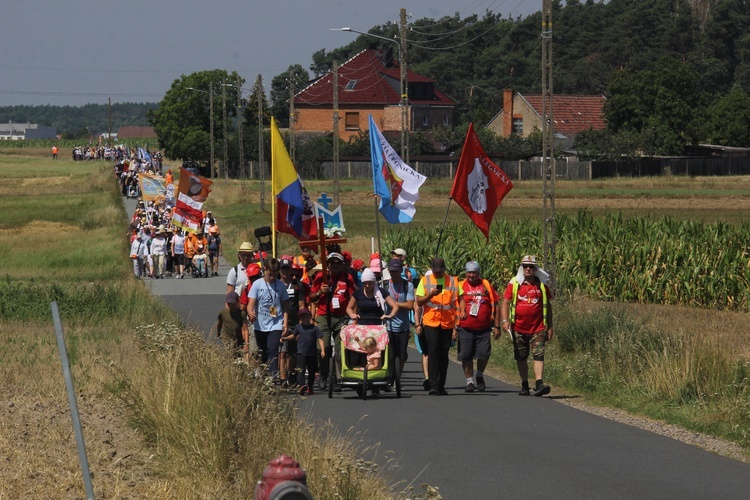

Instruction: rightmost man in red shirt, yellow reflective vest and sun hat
[496,255,554,396]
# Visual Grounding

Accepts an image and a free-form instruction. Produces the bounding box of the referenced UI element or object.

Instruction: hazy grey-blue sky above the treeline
[0,0,542,106]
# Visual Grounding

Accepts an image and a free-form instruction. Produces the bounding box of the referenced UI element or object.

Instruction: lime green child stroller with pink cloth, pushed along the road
[328,325,401,399]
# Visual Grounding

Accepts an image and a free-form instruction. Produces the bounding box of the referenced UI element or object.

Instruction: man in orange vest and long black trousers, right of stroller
[415,257,458,396]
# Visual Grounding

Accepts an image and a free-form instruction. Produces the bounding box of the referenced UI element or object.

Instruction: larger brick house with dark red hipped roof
[294,49,456,140]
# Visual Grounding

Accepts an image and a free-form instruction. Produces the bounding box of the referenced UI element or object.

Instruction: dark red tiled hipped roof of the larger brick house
[294,49,456,106]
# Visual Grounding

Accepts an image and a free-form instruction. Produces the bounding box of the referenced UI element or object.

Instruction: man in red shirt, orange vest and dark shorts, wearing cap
[457,260,499,392]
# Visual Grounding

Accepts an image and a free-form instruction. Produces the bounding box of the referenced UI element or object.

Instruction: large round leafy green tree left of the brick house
[148,69,244,163]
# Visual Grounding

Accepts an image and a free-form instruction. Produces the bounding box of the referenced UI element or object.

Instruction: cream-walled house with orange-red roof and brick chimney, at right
[487,89,607,149]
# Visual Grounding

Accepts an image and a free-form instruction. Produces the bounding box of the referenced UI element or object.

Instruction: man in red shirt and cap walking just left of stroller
[309,252,356,390]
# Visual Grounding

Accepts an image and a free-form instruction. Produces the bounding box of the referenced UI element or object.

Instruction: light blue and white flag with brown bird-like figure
[370,115,427,224]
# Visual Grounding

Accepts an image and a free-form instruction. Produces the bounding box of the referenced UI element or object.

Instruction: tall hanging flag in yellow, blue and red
[271,118,318,241]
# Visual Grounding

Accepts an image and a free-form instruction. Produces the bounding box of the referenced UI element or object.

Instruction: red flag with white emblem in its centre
[450,123,513,241]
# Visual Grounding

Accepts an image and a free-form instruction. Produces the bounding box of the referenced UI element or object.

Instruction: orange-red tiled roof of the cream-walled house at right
[520,94,607,133]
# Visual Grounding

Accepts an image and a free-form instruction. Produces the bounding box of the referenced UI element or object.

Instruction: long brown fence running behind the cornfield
[244,157,750,181]
